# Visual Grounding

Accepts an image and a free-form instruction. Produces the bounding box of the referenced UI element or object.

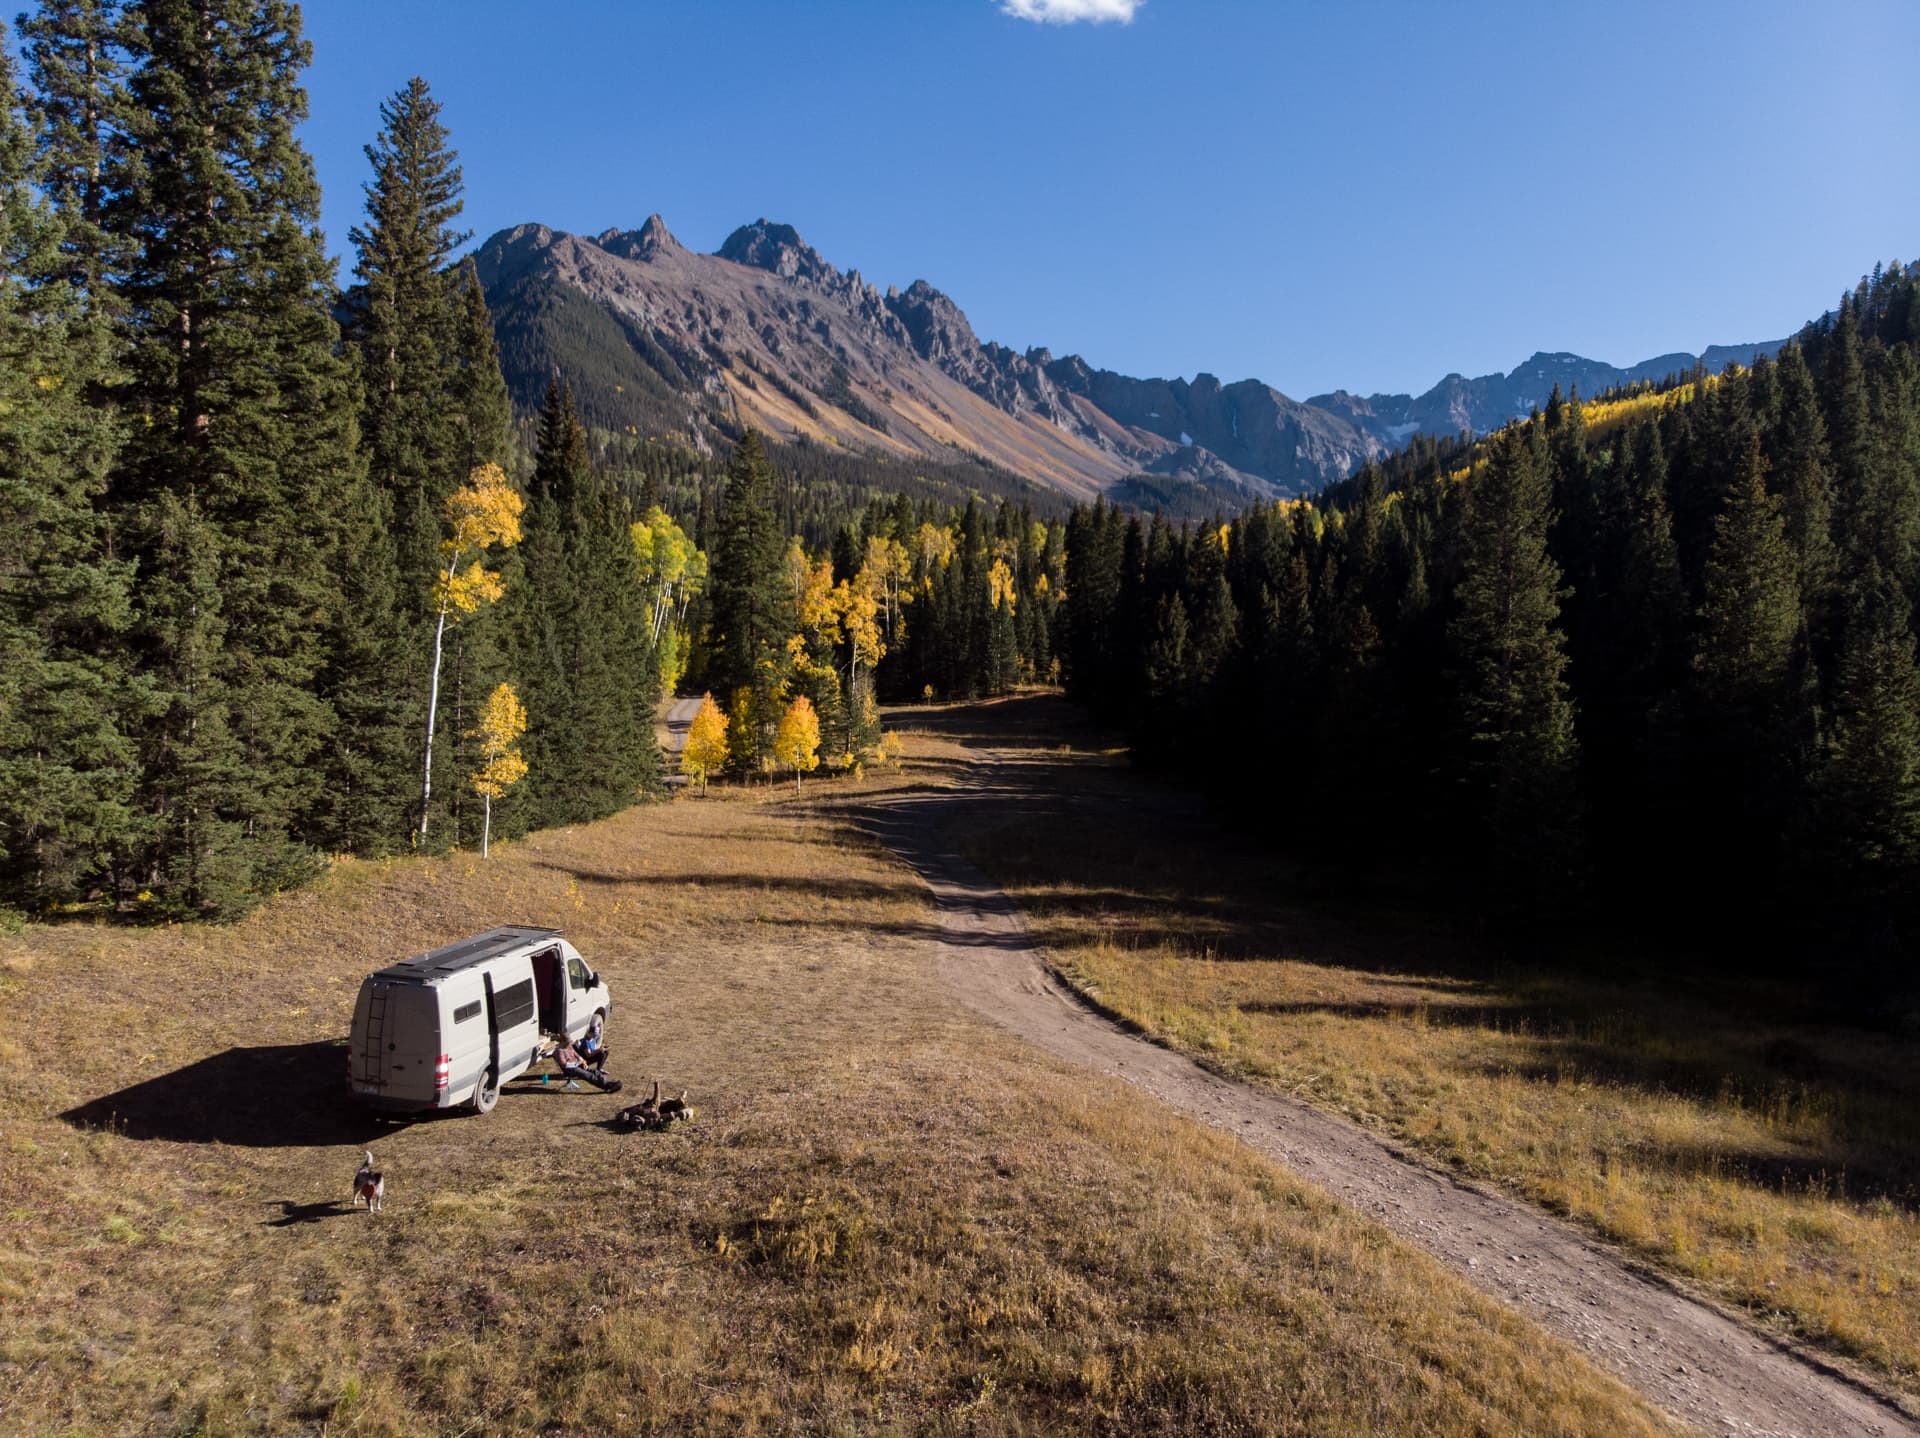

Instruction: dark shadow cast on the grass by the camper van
[60,1039,397,1148]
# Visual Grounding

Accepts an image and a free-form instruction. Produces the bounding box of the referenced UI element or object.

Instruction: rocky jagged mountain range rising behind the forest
[476,215,1784,503]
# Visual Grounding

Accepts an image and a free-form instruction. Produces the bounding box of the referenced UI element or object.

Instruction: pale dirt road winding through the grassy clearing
[860,751,1920,1438]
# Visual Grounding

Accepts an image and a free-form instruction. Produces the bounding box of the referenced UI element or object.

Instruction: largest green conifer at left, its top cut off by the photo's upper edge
[104,0,357,914]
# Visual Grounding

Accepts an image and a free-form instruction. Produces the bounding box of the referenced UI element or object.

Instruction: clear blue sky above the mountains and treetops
[305,0,1920,397]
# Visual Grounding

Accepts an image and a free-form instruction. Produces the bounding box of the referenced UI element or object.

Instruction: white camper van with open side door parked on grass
[348,927,612,1114]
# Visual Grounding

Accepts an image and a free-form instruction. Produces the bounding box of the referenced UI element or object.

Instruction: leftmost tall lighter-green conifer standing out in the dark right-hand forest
[1448,424,1578,906]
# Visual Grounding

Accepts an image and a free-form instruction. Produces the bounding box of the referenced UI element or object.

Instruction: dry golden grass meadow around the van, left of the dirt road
[0,721,1681,1438]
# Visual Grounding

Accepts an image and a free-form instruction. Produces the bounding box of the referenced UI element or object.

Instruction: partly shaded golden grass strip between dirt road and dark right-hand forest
[948,691,1920,1394]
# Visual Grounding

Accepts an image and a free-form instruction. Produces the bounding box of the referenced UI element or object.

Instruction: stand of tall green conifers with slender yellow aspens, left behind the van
[0,0,662,918]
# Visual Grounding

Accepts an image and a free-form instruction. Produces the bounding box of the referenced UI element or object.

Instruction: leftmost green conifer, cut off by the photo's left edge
[0,28,136,908]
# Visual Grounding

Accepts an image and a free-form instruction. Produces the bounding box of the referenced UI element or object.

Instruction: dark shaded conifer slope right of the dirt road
[1064,265,1920,960]
